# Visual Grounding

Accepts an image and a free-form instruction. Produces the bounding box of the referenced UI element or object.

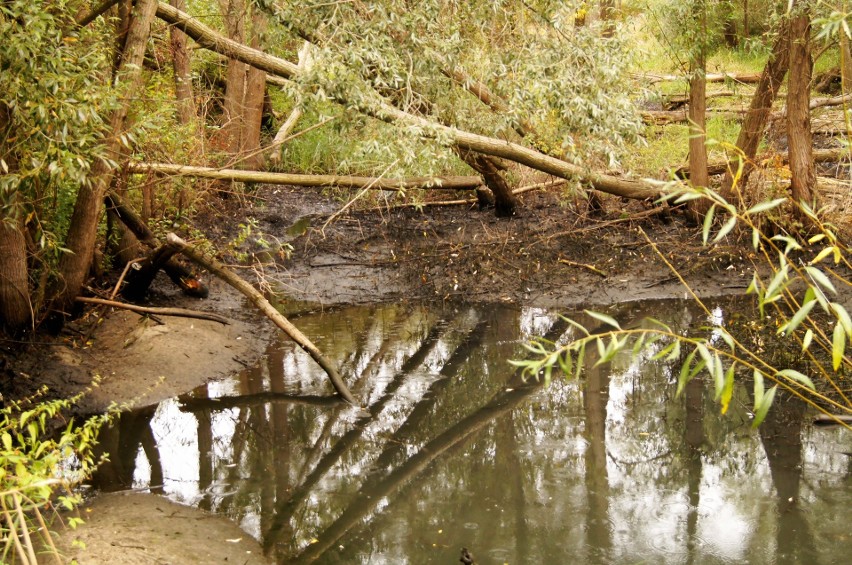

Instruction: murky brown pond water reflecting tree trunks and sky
[96,301,852,565]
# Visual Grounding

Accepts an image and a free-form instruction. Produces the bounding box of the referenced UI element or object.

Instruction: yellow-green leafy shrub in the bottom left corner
[0,390,117,563]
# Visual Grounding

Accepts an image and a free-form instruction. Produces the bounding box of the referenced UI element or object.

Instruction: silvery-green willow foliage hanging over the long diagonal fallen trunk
[260,0,640,165]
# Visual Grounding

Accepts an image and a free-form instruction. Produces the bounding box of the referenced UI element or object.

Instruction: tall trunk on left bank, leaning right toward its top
[55,0,157,309]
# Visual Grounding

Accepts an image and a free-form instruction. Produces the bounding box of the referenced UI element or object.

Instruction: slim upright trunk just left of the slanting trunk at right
[687,0,710,221]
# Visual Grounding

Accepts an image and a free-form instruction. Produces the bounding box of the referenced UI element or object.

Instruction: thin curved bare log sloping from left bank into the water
[166,233,357,405]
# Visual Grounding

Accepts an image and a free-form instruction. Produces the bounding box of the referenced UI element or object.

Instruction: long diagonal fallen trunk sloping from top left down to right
[157,2,662,200]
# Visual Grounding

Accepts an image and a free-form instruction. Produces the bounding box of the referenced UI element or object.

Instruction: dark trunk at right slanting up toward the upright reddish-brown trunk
[721,21,790,202]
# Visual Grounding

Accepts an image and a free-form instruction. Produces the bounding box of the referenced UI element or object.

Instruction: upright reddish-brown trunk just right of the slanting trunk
[787,2,816,213]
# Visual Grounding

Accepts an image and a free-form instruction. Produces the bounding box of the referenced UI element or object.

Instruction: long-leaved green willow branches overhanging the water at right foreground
[513,185,852,426]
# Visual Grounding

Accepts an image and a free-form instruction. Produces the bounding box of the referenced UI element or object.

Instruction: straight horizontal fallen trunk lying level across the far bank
[127,163,482,191]
